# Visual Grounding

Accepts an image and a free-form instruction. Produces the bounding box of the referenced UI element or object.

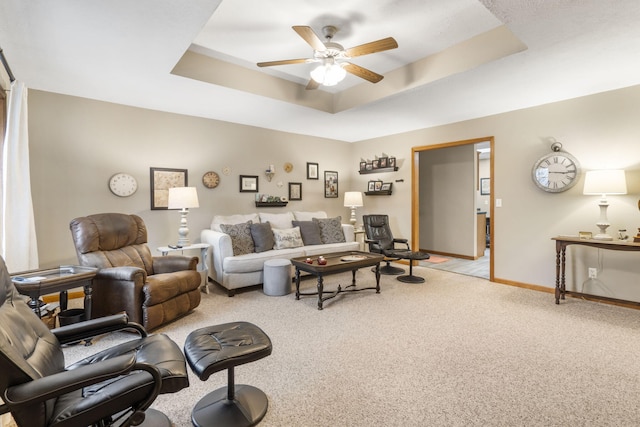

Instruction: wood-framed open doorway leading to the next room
[411,136,495,281]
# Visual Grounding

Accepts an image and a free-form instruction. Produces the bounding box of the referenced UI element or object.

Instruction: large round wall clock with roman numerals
[531,142,580,193]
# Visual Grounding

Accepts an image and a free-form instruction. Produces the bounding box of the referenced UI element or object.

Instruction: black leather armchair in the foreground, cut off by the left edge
[0,257,189,427]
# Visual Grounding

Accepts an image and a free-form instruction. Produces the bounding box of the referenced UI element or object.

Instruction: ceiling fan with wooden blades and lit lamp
[257,25,398,90]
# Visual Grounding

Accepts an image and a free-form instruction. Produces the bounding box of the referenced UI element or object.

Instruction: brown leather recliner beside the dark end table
[70,213,201,330]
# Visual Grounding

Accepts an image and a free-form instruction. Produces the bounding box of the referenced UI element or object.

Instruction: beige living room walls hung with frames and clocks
[29,87,640,301]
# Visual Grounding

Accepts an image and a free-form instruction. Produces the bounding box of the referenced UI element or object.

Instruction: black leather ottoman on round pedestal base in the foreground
[184,322,272,427]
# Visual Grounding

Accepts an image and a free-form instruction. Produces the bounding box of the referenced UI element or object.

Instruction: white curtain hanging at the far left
[0,81,39,272]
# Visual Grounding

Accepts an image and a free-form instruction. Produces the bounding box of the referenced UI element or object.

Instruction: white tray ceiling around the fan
[0,0,640,142]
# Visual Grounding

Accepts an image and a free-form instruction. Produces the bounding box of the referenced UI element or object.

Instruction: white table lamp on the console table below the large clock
[583,170,627,240]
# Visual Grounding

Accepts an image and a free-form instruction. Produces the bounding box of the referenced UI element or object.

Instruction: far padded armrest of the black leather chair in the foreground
[51,313,147,344]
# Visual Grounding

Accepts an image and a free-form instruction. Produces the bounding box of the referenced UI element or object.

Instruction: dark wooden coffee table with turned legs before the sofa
[291,251,384,310]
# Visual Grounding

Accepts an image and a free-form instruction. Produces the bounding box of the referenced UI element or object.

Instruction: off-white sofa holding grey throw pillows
[200,211,360,296]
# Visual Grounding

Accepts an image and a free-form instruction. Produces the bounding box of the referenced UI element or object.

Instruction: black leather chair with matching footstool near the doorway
[362,215,429,283]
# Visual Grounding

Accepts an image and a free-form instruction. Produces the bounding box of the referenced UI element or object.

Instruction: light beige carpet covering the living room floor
[65,267,640,427]
